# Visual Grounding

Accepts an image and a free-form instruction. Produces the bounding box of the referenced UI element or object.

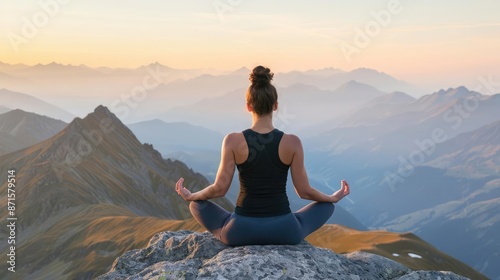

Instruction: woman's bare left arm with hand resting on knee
[175,134,236,201]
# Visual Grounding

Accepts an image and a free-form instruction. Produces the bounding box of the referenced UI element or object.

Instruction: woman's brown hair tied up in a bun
[247,66,278,116]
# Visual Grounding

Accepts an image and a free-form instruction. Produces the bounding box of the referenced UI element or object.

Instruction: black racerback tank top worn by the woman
[235,129,291,217]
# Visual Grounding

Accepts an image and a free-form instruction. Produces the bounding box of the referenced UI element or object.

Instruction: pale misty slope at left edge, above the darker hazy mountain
[0,89,75,121]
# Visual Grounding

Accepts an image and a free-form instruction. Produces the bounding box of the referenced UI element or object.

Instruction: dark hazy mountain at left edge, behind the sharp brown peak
[0,109,66,155]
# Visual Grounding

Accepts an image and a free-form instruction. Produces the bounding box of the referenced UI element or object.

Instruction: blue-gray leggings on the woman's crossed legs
[189,200,335,246]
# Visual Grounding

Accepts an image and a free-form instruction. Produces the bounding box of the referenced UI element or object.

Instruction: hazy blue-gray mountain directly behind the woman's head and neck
[159,81,386,134]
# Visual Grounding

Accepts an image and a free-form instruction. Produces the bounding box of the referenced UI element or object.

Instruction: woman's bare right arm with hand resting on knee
[289,135,350,203]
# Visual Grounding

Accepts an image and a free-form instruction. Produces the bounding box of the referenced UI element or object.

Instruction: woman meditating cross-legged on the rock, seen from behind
[176,66,349,246]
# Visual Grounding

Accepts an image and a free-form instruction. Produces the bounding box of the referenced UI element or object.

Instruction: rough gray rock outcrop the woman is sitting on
[96,231,467,280]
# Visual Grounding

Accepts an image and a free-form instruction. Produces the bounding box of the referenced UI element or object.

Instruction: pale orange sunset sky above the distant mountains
[0,0,500,91]
